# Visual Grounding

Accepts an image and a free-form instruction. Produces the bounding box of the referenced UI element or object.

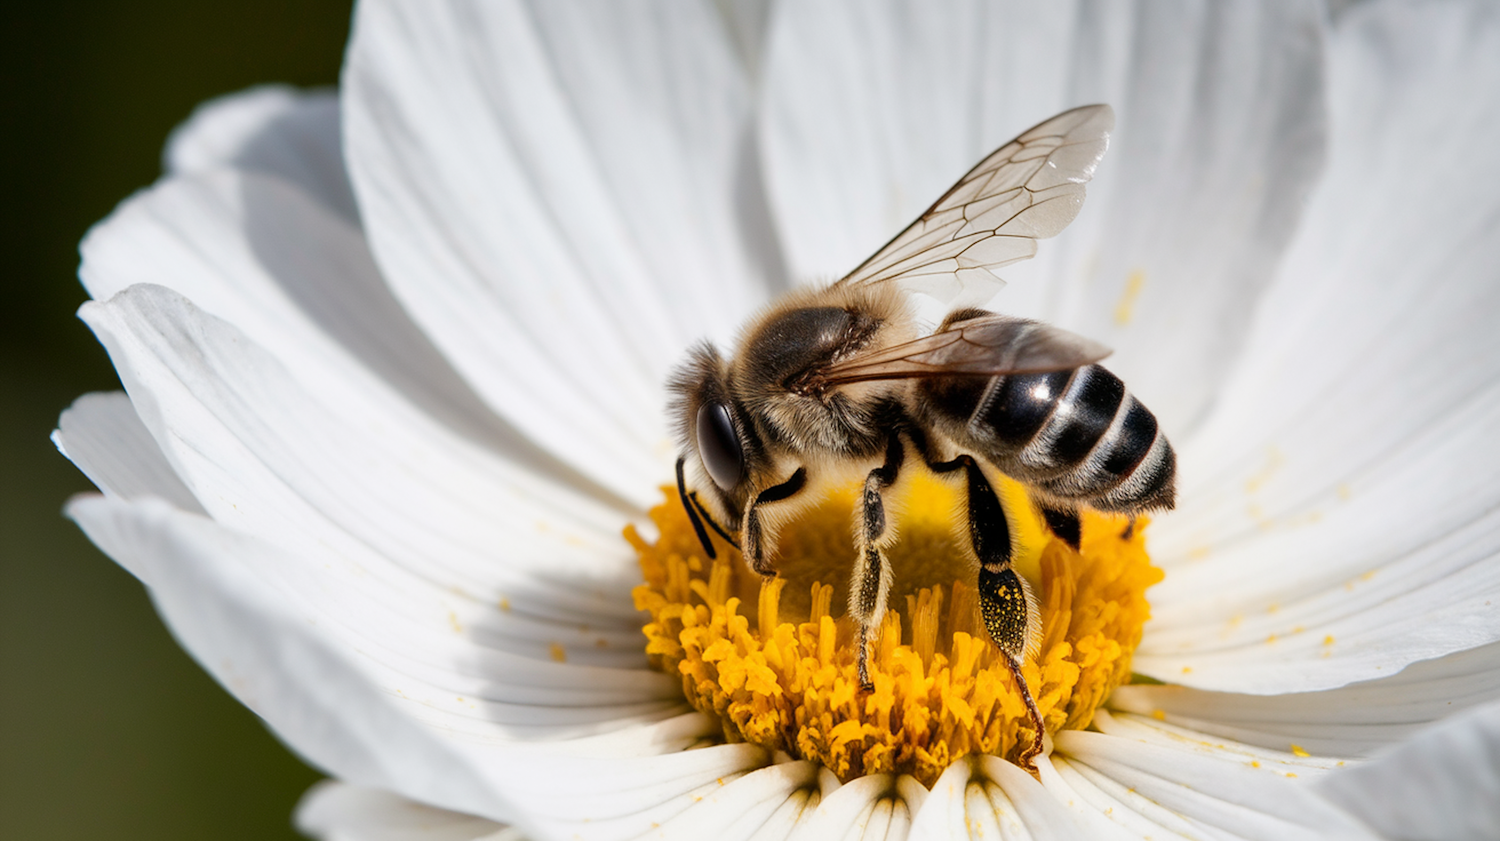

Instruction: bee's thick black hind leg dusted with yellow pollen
[929,456,1047,777]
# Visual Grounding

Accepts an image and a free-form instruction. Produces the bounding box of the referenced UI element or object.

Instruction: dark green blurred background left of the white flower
[0,0,350,841]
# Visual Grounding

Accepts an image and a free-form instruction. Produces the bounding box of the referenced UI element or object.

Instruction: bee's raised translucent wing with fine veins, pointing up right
[839,105,1115,301]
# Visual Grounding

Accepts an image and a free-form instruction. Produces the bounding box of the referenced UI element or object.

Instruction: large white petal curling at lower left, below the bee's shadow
[69,496,789,837]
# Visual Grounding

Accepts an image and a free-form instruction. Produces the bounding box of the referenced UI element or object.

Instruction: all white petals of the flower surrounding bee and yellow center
[57,1,1500,840]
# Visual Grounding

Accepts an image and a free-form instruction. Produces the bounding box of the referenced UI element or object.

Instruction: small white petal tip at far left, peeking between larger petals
[53,391,203,513]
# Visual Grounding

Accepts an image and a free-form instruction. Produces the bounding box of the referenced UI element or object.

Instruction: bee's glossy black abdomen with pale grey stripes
[917,364,1176,514]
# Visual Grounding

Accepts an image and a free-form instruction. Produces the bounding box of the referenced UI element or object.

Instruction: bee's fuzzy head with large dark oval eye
[668,342,765,531]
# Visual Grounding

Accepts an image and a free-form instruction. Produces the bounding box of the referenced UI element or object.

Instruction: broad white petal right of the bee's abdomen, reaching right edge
[1136,3,1500,693]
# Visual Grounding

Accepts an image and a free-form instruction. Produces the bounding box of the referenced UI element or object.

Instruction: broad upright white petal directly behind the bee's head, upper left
[344,3,776,505]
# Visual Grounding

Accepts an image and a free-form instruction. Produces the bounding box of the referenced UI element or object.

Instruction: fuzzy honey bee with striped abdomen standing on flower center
[669,105,1176,771]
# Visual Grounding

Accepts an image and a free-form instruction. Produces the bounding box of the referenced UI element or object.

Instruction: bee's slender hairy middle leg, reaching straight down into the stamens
[849,435,906,691]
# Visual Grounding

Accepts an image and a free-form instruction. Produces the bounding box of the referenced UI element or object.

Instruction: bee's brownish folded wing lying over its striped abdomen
[809,315,1110,388]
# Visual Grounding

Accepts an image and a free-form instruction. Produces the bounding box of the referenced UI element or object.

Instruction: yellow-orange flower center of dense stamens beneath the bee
[626,474,1161,786]
